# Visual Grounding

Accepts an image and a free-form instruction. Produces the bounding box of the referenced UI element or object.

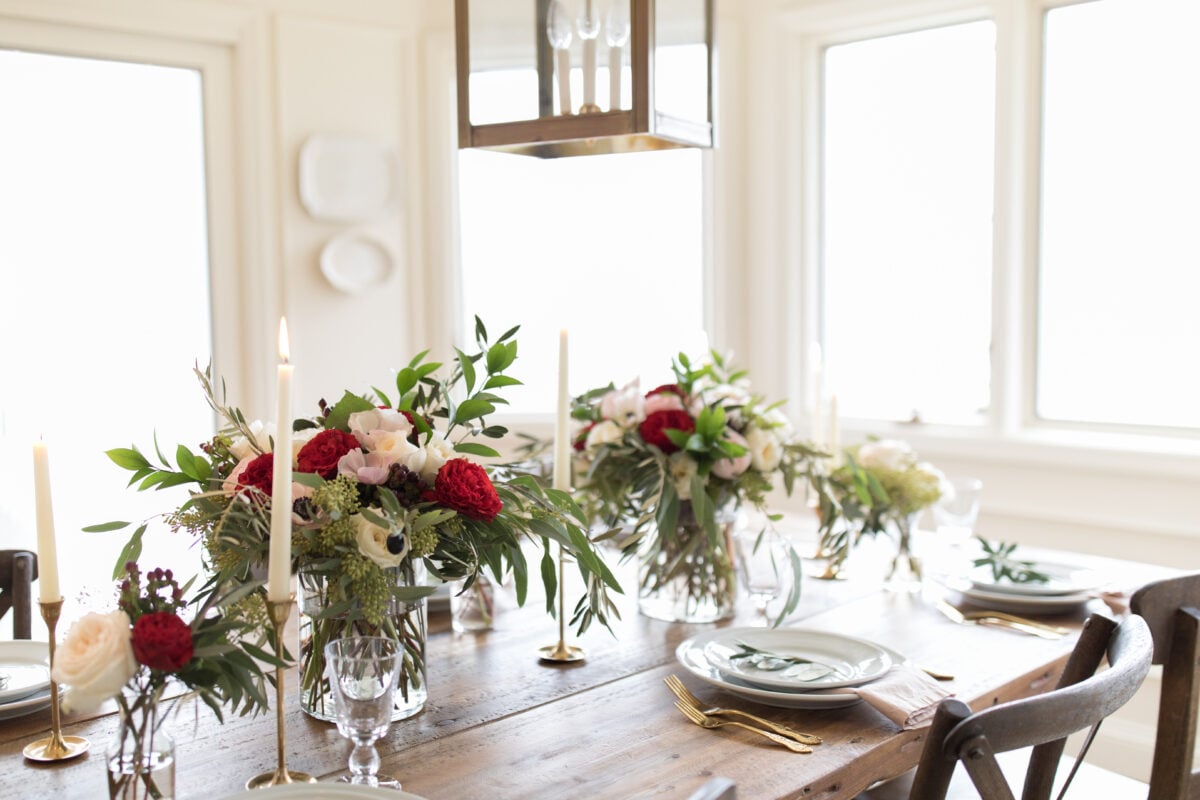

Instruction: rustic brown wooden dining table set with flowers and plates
[0,532,1171,800]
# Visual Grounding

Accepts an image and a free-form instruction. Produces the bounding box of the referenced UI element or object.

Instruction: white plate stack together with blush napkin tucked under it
[676,627,950,729]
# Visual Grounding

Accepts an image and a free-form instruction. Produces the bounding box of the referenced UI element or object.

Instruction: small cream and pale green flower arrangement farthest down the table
[820,439,947,589]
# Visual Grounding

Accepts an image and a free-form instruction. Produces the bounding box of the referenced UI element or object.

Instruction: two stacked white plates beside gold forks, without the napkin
[676,627,904,709]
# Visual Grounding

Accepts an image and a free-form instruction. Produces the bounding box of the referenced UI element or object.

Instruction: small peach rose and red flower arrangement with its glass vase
[53,561,274,800]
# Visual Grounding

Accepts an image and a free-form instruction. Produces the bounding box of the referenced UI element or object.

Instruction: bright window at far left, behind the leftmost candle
[0,50,212,613]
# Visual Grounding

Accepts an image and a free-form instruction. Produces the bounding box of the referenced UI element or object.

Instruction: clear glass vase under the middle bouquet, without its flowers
[637,500,737,622]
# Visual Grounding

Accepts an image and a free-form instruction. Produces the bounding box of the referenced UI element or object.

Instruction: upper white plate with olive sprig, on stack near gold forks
[704,627,892,692]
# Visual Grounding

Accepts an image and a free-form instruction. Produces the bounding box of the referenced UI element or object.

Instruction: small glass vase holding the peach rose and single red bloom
[104,686,175,800]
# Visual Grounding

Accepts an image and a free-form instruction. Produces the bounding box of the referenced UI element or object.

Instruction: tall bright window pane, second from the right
[821,22,995,422]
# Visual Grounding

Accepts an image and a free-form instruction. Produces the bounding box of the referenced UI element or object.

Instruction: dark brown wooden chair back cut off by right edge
[1129,575,1200,800]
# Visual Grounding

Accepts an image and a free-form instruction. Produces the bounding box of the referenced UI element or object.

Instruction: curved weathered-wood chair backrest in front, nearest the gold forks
[908,615,1153,800]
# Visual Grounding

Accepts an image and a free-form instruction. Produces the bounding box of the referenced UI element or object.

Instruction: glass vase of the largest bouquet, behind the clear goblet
[298,560,428,722]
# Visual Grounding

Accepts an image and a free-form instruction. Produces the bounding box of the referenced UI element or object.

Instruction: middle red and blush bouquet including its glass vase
[572,353,838,621]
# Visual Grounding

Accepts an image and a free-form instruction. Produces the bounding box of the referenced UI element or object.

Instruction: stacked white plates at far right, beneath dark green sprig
[947,561,1105,614]
